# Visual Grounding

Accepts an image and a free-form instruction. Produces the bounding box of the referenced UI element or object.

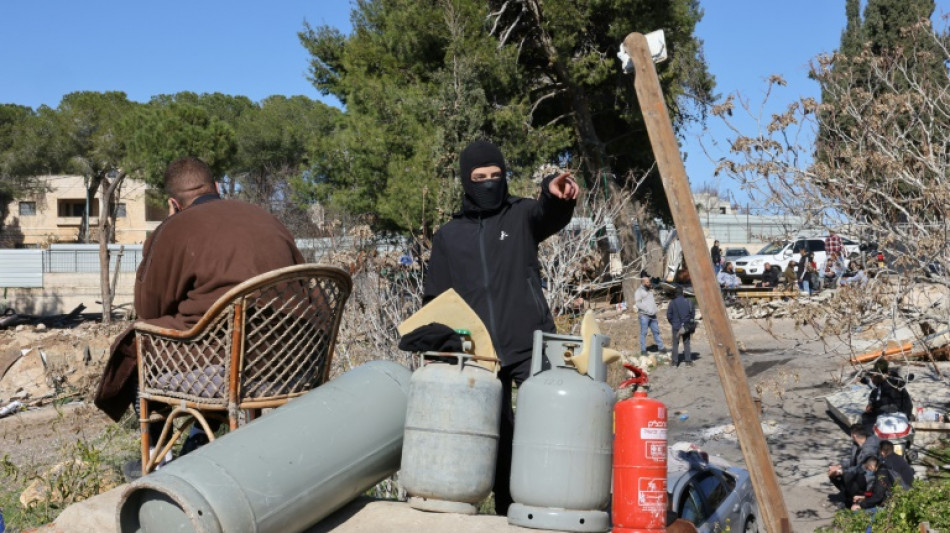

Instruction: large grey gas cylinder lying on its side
[117,361,411,533]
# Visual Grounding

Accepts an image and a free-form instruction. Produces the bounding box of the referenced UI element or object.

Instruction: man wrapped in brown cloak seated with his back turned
[95,157,304,456]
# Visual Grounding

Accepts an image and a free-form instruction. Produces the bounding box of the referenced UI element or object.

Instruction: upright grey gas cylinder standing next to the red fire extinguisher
[508,331,614,531]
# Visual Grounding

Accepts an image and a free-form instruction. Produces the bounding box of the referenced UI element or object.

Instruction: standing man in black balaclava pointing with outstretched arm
[424,140,578,515]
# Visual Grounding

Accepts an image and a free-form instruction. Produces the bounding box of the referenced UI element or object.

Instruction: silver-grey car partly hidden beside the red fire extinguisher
[666,463,759,533]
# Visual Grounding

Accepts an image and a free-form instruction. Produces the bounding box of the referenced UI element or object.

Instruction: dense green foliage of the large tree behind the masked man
[300,0,713,230]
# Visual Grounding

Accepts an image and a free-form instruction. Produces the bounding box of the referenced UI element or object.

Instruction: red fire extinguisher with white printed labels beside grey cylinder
[612,364,667,533]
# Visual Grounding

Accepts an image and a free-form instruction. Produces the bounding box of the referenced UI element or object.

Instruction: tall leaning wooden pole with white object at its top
[624,33,791,533]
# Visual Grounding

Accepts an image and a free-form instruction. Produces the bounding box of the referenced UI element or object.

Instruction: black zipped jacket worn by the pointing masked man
[423,177,575,366]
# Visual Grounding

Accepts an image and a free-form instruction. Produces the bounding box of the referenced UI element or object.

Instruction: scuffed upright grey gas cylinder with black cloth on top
[399,353,501,514]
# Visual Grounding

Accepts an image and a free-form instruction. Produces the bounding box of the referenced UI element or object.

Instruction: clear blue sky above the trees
[0,0,950,201]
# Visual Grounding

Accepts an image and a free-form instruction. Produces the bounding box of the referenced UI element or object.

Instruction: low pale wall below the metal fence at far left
[0,272,135,316]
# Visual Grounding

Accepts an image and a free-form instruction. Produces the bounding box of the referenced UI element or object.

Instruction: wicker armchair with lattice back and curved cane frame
[135,265,352,474]
